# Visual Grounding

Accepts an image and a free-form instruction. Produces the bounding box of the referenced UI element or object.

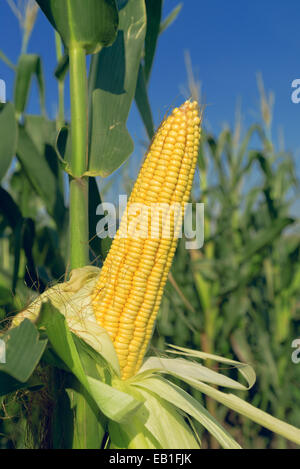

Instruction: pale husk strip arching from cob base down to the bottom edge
[136,376,240,449]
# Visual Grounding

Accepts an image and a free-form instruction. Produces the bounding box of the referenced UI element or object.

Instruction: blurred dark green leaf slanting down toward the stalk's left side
[17,125,64,225]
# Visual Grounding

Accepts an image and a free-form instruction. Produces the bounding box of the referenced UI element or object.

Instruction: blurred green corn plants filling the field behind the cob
[0,0,300,449]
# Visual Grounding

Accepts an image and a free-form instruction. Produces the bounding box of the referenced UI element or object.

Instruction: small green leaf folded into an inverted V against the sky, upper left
[14,54,45,115]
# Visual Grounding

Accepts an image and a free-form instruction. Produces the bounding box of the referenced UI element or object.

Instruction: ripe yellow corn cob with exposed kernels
[92,101,201,379]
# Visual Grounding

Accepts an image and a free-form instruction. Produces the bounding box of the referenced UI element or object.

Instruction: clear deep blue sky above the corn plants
[0,0,300,176]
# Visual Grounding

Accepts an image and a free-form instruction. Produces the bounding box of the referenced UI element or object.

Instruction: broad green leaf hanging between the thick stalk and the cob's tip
[88,0,146,177]
